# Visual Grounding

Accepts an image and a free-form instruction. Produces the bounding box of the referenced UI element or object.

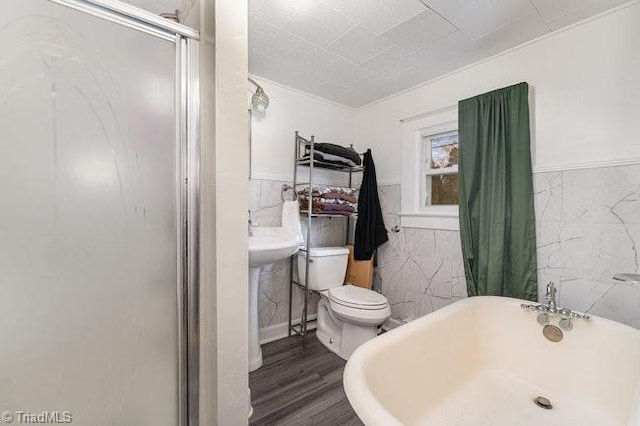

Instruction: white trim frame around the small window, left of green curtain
[399,105,460,231]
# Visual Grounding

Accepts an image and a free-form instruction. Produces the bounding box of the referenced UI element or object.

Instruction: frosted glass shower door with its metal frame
[0,0,199,425]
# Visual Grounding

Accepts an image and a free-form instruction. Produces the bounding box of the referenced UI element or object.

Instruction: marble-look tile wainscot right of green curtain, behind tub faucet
[535,165,640,328]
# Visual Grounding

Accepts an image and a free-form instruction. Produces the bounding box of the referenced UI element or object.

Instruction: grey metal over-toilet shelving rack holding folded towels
[288,131,364,337]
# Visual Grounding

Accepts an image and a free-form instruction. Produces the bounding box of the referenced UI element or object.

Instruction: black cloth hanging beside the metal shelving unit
[353,149,389,260]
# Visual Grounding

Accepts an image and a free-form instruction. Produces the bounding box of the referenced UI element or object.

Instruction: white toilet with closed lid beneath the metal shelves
[298,247,391,359]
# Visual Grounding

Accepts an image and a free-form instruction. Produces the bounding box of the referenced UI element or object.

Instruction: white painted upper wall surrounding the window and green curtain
[356,2,640,182]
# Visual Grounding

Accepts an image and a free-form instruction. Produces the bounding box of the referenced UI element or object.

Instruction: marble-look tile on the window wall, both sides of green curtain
[374,165,640,328]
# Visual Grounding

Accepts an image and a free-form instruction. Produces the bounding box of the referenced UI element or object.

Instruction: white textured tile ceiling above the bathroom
[249,0,628,107]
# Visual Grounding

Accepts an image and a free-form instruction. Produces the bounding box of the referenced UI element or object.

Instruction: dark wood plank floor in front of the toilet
[249,332,362,426]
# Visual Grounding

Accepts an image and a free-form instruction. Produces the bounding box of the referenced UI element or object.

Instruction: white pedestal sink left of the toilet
[249,227,299,371]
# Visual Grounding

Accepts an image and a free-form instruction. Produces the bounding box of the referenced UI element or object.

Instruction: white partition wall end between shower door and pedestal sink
[200,0,249,426]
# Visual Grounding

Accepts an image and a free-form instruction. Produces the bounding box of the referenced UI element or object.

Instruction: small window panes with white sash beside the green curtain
[420,130,458,210]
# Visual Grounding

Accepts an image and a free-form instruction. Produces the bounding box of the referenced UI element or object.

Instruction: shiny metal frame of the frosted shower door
[49,0,200,426]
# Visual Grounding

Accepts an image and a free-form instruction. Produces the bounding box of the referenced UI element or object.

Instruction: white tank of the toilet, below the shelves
[298,247,349,291]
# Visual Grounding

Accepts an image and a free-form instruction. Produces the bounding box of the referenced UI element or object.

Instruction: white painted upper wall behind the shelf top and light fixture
[247,76,361,180]
